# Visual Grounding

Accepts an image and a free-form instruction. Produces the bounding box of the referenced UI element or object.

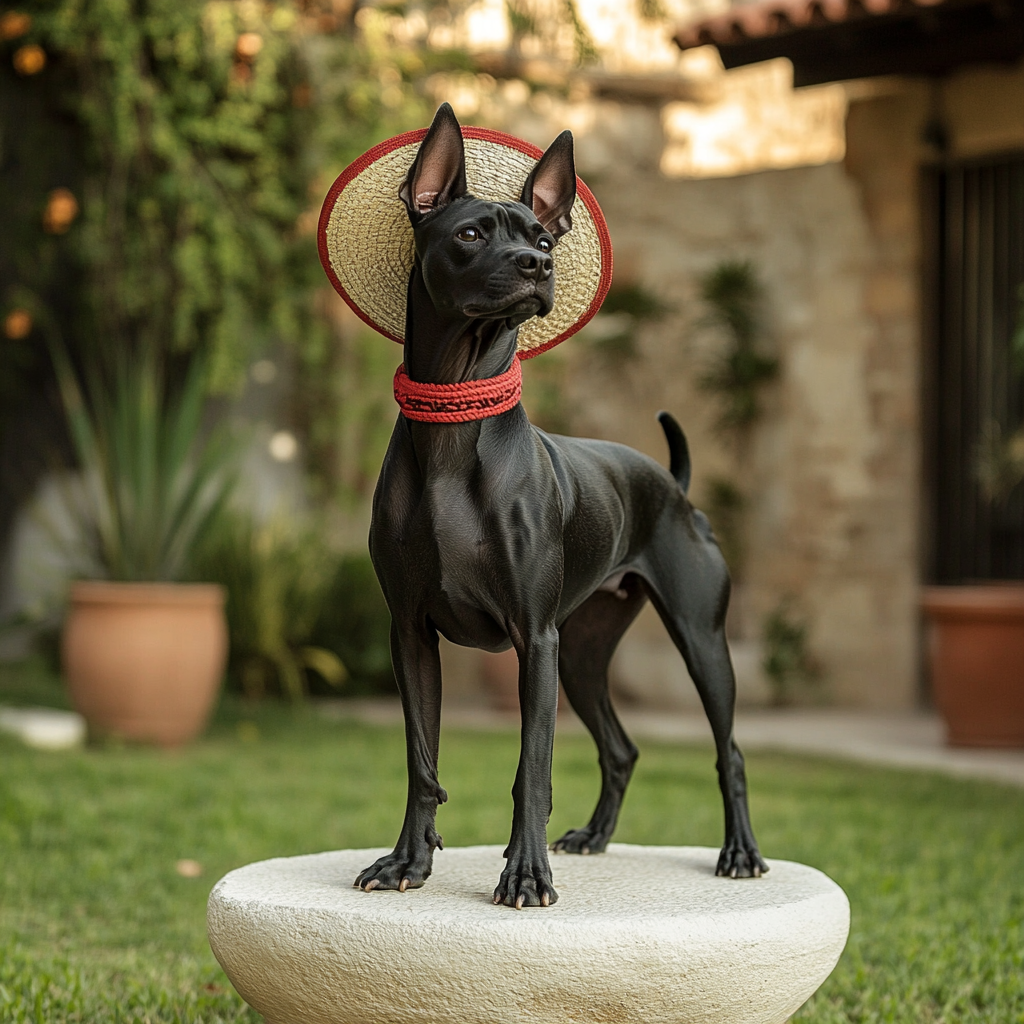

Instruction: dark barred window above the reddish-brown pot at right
[925,155,1024,584]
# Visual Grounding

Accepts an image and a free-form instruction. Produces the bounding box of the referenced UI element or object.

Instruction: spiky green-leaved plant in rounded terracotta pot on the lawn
[52,344,231,745]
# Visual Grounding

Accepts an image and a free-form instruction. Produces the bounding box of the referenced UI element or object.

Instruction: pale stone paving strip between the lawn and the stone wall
[322,700,1024,786]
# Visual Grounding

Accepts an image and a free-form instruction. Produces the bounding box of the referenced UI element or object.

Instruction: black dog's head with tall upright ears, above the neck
[398,103,575,327]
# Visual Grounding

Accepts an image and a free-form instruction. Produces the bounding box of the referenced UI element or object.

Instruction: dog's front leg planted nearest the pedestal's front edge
[495,626,558,910]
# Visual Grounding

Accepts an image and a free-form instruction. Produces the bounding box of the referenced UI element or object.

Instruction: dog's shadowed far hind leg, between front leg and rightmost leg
[551,574,647,853]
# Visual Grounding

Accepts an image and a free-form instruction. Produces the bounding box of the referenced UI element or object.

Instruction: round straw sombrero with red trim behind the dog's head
[317,127,611,359]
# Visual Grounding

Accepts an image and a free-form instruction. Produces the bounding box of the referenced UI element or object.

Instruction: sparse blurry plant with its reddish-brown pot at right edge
[922,323,1024,746]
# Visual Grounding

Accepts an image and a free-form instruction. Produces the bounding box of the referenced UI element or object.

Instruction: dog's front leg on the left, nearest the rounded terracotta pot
[355,622,447,892]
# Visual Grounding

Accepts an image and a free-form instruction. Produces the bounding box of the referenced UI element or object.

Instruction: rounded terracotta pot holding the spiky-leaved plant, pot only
[61,583,227,746]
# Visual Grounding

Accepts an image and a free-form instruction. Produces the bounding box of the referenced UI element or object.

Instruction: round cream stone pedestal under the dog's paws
[207,844,850,1024]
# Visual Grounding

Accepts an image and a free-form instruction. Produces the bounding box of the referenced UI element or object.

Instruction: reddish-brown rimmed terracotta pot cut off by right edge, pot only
[922,584,1024,746]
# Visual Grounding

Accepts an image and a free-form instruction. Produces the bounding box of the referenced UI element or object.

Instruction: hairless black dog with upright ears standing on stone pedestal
[355,103,767,908]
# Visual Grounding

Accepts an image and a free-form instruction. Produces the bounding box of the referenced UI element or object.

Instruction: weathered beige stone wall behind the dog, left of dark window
[464,75,927,708]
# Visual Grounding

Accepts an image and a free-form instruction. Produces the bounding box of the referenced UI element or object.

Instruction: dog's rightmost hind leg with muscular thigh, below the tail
[643,520,768,879]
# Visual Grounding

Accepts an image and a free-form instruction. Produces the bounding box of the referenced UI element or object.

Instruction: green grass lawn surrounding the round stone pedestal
[0,667,1024,1024]
